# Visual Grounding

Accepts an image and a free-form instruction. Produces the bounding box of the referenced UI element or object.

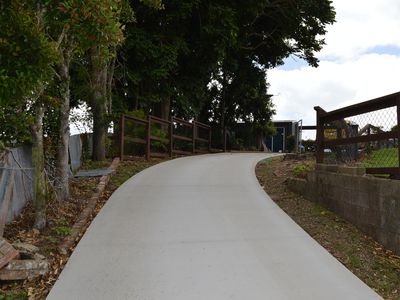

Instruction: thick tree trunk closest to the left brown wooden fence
[90,46,108,161]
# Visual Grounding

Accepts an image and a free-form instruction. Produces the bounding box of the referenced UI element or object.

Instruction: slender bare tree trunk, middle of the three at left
[55,50,71,201]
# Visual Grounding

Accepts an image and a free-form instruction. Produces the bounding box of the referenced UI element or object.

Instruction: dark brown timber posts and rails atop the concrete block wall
[314,92,400,176]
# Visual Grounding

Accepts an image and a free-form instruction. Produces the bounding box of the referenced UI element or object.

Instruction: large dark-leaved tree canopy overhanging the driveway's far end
[119,0,334,131]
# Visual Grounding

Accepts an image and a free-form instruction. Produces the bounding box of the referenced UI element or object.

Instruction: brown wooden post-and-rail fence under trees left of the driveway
[120,114,211,160]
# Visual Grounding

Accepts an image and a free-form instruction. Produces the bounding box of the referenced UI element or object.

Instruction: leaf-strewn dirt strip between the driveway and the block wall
[256,158,400,300]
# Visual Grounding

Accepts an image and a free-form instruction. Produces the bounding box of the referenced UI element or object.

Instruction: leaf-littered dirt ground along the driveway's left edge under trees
[0,158,163,300]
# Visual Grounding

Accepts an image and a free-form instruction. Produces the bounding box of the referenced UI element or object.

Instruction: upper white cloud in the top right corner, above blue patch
[319,0,400,60]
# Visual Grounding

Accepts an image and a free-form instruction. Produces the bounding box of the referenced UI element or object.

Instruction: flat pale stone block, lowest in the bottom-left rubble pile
[0,260,49,280]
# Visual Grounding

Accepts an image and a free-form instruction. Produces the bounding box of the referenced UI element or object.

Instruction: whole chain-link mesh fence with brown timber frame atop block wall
[316,93,400,174]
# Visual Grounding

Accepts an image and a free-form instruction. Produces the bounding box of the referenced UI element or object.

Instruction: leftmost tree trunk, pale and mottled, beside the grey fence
[31,103,46,229]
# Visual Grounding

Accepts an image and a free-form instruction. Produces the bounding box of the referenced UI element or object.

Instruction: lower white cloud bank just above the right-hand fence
[268,54,400,120]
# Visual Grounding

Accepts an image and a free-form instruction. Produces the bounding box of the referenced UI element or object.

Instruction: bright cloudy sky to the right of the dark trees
[268,0,400,137]
